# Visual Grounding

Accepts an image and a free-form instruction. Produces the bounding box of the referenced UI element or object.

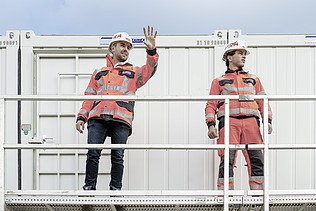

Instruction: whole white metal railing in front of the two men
[0,95,316,211]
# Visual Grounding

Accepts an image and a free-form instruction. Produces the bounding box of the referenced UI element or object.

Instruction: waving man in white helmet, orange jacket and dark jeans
[76,26,159,190]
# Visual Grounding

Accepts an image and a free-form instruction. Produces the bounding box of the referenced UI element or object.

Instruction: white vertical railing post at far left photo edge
[0,98,5,210]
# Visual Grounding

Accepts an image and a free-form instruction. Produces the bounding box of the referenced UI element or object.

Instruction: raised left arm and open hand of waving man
[137,26,159,88]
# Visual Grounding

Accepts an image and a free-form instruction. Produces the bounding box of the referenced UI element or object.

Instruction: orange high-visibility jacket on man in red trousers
[205,70,272,127]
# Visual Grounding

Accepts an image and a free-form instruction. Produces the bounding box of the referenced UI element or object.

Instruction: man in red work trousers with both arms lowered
[205,40,272,190]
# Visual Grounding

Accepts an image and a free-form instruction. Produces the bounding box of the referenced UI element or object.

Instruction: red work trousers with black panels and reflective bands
[217,117,264,190]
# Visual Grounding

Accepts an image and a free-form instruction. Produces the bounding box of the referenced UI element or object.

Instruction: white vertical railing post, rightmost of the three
[263,97,269,211]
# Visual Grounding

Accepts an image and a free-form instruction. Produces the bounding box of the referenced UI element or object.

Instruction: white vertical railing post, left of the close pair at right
[223,98,229,211]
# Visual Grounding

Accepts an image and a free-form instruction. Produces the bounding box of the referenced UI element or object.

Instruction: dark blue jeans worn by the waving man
[83,119,130,190]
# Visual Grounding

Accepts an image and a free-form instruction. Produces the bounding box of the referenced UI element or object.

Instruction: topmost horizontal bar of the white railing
[0,95,316,101]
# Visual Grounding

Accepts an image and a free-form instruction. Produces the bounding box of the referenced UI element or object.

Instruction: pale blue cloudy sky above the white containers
[0,0,316,35]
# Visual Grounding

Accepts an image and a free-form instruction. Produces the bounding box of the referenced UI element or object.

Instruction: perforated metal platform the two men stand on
[5,191,316,211]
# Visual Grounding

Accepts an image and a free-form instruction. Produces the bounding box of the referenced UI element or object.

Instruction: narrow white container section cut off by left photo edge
[0,31,19,190]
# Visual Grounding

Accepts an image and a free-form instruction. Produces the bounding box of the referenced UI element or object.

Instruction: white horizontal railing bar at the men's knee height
[3,143,316,150]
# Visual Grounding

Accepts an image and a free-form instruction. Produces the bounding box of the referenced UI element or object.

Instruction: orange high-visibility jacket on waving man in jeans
[77,49,159,126]
